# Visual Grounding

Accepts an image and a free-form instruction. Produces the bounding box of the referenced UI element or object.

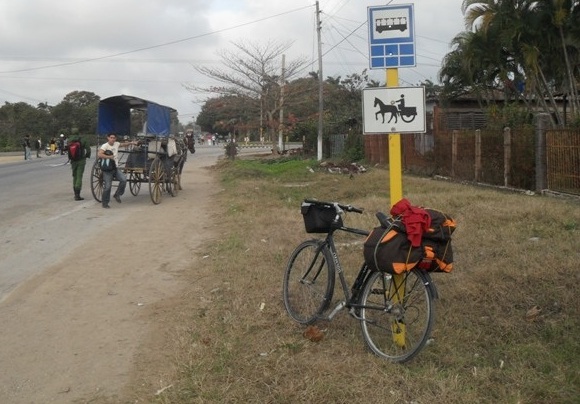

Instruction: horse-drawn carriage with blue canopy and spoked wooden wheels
[91,95,187,204]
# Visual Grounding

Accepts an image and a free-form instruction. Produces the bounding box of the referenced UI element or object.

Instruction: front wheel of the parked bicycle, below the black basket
[283,240,334,324]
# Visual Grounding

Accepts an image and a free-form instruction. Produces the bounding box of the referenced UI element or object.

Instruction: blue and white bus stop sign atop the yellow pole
[368,4,417,69]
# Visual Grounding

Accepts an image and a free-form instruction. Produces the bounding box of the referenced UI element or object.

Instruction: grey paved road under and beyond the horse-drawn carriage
[0,146,268,301]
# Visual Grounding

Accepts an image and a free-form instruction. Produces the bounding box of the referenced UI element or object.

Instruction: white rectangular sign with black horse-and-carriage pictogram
[363,87,426,134]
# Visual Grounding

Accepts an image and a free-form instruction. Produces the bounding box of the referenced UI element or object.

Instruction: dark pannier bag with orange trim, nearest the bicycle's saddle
[363,226,423,274]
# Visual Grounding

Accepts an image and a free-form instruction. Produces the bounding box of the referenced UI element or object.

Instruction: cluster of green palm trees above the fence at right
[440,0,580,124]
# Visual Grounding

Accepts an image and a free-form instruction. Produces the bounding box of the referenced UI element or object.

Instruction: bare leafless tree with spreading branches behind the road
[186,41,306,140]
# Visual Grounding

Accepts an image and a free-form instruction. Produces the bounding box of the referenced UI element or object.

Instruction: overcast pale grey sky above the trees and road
[0,0,464,123]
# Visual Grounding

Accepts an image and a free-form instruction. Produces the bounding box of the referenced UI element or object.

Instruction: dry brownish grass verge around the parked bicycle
[155,156,580,404]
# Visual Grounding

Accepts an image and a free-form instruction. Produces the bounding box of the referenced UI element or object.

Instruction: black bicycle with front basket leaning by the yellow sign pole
[283,199,437,363]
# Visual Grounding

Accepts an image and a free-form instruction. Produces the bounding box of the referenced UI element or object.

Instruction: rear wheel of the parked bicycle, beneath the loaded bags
[359,269,435,363]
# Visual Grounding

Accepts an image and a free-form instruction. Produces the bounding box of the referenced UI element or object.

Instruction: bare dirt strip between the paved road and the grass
[0,155,216,404]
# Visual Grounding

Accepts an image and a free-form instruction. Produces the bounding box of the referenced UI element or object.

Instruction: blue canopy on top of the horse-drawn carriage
[97,95,177,137]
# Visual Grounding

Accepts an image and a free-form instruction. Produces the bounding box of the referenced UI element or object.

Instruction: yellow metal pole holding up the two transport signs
[385,68,406,348]
